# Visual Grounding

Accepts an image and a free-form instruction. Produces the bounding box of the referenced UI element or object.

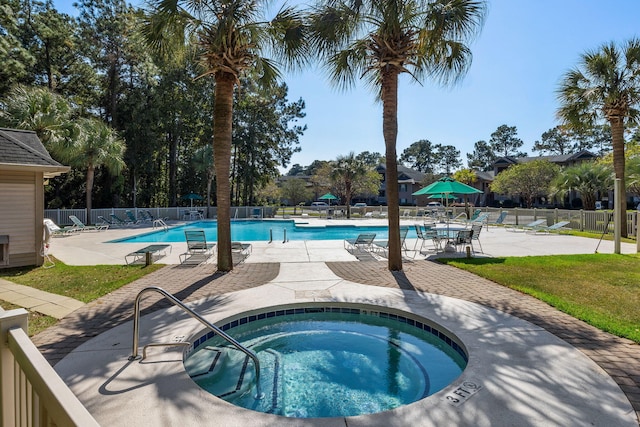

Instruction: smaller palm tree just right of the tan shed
[64,118,125,221]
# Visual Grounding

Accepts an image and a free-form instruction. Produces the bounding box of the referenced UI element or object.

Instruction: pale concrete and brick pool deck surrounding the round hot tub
[25,219,640,426]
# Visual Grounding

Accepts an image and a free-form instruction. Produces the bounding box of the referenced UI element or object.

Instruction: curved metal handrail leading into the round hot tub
[129,286,264,399]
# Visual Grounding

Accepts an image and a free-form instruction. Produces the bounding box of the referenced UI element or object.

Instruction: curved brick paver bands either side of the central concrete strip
[28,261,640,424]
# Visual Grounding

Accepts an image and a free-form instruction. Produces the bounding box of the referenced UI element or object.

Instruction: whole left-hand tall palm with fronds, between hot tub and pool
[143,0,306,271]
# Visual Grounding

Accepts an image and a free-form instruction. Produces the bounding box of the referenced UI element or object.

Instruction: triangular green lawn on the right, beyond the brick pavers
[442,254,640,343]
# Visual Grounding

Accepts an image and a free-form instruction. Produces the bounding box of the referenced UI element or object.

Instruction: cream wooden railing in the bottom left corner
[0,308,99,427]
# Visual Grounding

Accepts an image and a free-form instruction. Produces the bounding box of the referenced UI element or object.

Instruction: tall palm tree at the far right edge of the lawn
[558,39,640,241]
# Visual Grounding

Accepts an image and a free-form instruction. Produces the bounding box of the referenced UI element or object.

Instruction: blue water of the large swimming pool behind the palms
[113,220,416,243]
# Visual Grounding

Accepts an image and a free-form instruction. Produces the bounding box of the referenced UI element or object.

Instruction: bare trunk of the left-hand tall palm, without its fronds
[213,72,235,271]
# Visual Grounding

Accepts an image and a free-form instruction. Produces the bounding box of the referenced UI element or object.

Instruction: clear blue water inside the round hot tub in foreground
[185,313,466,418]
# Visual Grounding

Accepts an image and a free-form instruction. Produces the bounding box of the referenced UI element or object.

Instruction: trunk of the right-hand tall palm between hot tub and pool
[382,67,402,271]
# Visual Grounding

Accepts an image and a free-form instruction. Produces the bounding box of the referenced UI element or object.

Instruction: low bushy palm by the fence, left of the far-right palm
[550,162,613,210]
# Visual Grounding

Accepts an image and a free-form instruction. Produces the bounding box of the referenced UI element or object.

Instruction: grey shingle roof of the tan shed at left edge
[0,128,69,177]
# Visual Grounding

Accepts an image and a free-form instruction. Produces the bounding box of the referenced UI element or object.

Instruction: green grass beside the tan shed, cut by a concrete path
[0,260,163,336]
